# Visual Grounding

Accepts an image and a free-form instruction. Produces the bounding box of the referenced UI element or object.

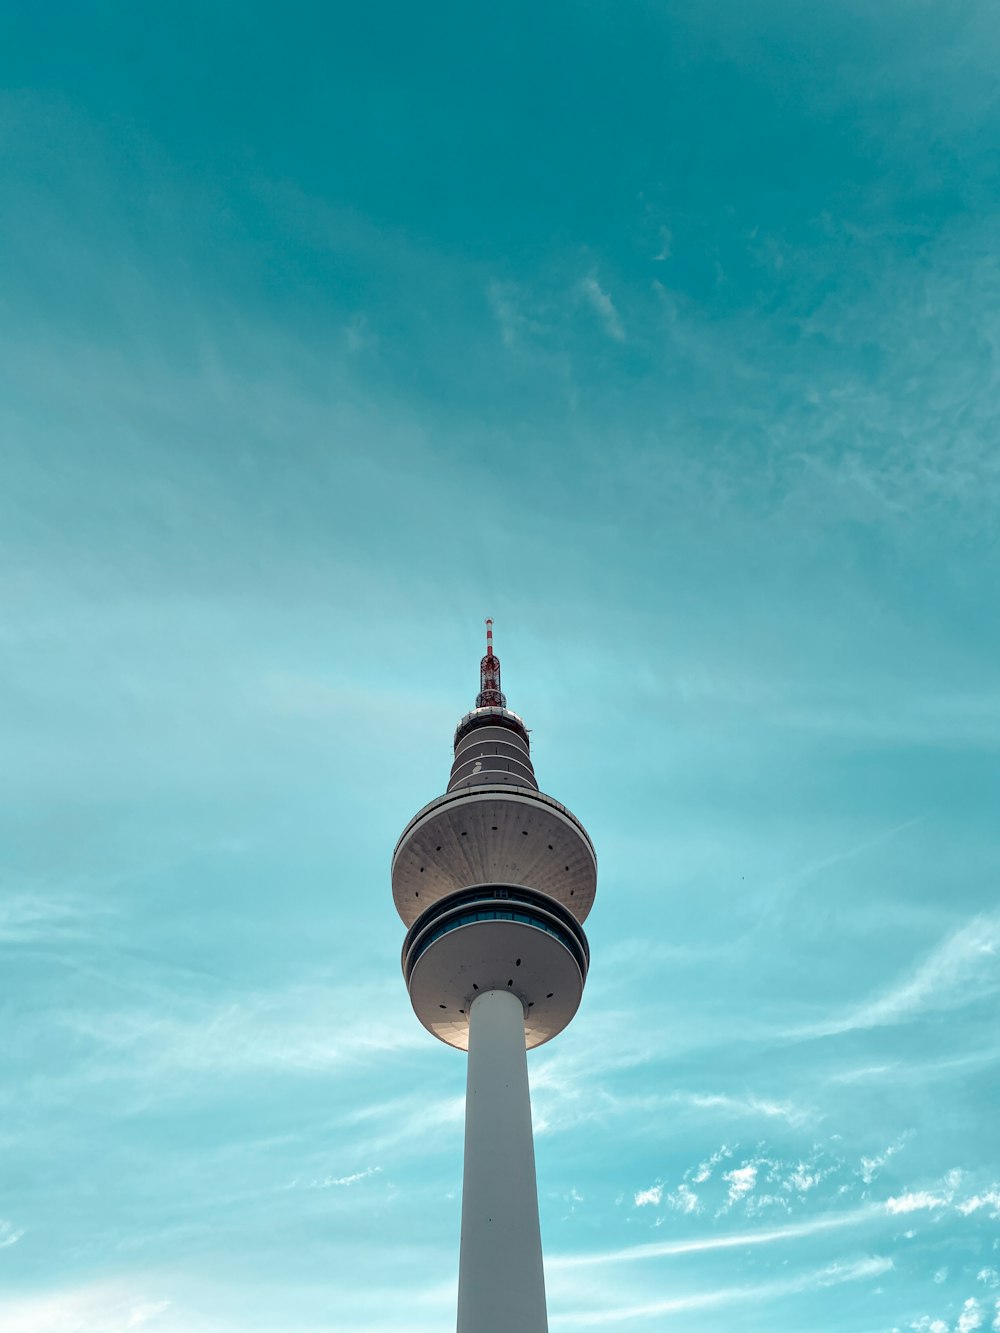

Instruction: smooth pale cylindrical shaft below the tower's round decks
[457,990,548,1333]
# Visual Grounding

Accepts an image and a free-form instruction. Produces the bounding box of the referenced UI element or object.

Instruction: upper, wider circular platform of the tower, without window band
[392,784,597,925]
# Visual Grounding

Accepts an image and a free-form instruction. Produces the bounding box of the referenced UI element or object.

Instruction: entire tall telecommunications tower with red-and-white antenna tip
[392,620,597,1333]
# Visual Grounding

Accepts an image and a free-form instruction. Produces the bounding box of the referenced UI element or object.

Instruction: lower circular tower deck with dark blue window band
[403,884,591,1050]
